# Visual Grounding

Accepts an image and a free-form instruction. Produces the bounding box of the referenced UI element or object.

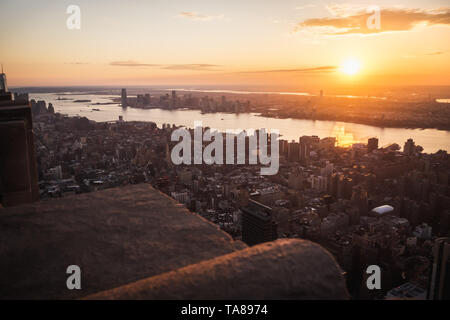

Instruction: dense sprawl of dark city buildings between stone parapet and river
[29,91,450,298]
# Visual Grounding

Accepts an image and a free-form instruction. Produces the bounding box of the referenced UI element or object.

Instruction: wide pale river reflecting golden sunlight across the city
[30,93,450,152]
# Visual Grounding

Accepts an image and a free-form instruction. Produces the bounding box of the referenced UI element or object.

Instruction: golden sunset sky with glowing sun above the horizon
[0,0,450,90]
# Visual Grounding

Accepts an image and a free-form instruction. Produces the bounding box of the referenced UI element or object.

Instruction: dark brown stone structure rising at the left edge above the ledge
[0,68,39,207]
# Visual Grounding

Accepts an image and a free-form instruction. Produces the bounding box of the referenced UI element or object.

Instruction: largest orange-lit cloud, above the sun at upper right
[293,5,450,35]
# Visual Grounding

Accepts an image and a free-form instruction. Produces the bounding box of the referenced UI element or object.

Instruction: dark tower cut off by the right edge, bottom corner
[428,238,450,300]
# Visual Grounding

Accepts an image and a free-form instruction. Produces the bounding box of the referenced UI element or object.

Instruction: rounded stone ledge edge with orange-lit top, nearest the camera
[86,239,349,299]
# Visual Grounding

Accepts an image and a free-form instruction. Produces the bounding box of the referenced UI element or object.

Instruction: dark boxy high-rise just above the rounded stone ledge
[241,200,278,246]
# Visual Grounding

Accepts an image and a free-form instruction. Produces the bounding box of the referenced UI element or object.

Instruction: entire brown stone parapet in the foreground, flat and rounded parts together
[0,184,347,299]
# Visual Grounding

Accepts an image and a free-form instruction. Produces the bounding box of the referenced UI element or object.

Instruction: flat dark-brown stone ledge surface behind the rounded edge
[0,184,247,299]
